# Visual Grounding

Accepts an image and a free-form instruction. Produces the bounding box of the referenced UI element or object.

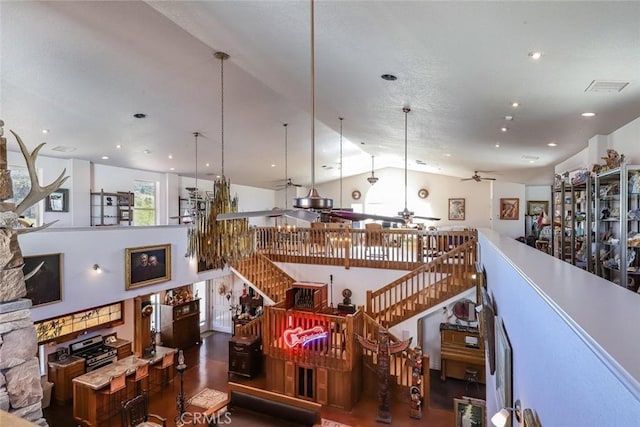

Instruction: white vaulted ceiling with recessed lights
[0,0,640,188]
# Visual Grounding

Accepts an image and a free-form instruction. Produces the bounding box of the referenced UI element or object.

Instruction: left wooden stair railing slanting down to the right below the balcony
[233,254,295,303]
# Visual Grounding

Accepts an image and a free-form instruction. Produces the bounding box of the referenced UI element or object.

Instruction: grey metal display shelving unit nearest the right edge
[594,163,640,292]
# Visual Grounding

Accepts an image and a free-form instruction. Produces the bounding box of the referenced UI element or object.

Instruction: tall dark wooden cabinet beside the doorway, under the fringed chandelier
[160,299,200,348]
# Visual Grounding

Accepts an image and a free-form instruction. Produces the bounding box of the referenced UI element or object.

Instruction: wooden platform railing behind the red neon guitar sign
[262,306,362,370]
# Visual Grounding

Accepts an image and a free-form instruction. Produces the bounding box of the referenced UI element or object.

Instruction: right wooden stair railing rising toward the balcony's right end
[366,239,476,327]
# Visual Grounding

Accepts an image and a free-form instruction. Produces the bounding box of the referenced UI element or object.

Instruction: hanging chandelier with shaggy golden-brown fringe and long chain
[188,52,253,269]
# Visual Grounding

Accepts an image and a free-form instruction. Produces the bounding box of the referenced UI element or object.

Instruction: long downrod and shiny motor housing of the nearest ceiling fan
[293,0,333,209]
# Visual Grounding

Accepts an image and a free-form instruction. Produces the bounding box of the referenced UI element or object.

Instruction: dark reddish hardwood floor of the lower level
[44,332,485,427]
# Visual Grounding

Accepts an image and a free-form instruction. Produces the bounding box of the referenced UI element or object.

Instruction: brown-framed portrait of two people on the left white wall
[125,243,171,291]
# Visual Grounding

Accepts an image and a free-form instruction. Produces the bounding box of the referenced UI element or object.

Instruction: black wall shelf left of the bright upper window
[90,190,134,226]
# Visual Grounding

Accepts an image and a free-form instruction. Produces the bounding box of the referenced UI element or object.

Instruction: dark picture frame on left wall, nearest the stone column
[23,253,63,307]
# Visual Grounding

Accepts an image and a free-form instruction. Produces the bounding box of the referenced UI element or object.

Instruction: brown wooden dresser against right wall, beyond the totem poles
[440,323,485,384]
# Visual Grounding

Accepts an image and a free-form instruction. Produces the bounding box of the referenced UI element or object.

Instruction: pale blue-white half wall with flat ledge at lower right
[479,230,640,426]
